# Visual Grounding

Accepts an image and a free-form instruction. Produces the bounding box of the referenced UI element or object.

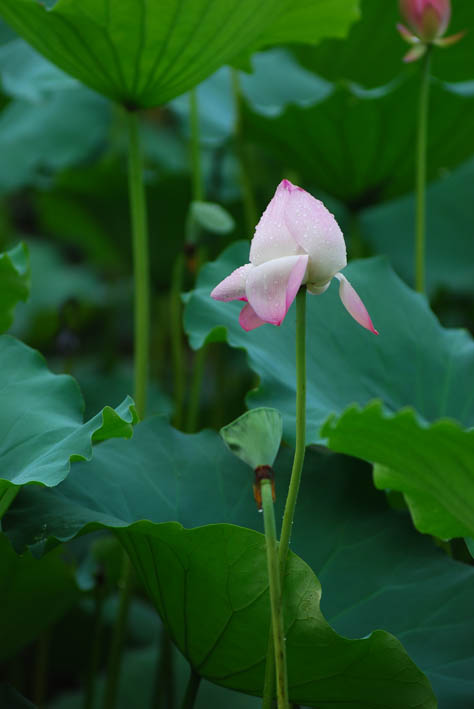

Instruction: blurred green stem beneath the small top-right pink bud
[415,46,431,293]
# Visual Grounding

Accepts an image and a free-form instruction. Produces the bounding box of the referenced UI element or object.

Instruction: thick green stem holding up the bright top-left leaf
[127,111,150,418]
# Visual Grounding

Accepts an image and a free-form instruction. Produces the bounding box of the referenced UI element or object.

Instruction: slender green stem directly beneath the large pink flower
[280,286,306,583]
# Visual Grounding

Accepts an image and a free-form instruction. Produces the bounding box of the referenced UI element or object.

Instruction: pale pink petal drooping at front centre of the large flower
[245,254,308,325]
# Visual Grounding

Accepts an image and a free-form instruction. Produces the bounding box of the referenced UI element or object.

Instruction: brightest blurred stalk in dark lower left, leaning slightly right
[102,551,133,709]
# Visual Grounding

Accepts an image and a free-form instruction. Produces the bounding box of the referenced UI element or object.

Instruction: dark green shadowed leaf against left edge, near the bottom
[0,533,79,660]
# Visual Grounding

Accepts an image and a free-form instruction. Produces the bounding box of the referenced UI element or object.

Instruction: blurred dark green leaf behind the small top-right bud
[296,0,474,88]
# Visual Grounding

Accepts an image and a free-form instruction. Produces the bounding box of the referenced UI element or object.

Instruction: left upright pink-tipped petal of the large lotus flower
[250,180,303,266]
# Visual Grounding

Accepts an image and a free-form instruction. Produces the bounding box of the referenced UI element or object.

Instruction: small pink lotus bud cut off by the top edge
[397,0,465,62]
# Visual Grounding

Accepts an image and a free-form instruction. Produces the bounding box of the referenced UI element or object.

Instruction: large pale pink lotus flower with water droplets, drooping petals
[211,180,378,335]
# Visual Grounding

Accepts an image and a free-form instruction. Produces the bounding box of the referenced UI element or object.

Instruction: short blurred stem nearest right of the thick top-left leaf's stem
[170,253,185,428]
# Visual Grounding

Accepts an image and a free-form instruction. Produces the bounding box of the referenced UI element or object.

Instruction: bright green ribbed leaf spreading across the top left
[0,0,358,107]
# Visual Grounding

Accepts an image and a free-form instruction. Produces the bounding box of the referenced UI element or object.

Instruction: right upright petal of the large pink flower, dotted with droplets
[285,189,347,287]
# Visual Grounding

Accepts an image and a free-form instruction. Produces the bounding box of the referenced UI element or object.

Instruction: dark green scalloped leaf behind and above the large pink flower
[245,78,474,209]
